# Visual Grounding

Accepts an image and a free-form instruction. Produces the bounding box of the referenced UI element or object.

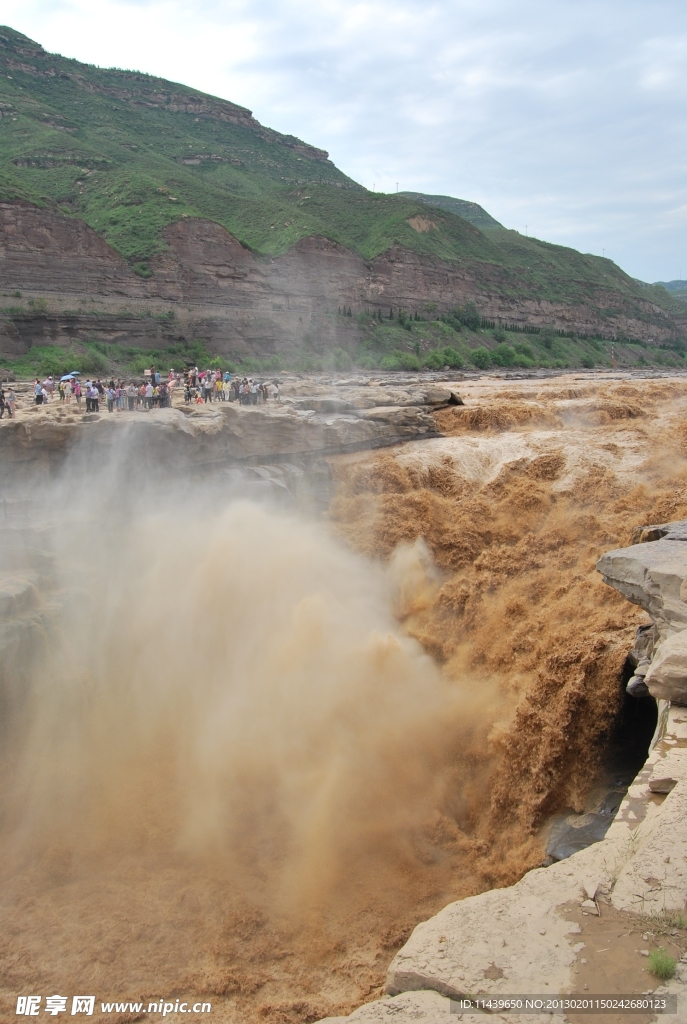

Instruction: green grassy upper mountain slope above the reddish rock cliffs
[0,28,684,331]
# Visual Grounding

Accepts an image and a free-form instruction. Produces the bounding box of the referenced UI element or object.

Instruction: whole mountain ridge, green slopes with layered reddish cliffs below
[0,28,687,376]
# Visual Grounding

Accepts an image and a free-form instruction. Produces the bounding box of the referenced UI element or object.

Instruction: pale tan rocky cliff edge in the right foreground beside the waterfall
[317,521,687,1024]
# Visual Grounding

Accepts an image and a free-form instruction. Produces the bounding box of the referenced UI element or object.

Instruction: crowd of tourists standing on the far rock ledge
[0,367,281,419]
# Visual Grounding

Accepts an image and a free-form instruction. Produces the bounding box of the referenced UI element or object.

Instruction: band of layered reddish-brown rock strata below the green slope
[0,203,687,356]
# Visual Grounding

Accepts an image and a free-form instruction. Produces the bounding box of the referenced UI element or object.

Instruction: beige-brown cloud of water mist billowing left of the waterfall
[0,448,497,1007]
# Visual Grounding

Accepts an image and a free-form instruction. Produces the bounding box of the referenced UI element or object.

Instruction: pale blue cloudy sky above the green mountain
[0,0,687,281]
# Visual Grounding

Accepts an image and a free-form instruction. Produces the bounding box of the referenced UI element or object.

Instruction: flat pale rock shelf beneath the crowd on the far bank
[0,381,459,473]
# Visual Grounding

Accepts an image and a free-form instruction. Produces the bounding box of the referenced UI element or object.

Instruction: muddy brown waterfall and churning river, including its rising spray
[0,378,687,1022]
